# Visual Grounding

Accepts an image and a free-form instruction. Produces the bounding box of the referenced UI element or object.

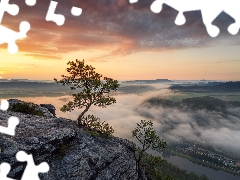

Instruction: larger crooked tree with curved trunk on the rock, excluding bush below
[54,59,119,124]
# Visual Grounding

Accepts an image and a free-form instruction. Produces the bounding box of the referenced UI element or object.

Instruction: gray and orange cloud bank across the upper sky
[0,0,239,61]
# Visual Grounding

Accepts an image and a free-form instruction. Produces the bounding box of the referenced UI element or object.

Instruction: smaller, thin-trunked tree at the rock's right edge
[132,120,167,176]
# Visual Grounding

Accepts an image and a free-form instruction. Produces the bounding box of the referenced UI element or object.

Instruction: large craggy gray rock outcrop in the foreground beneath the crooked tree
[0,111,145,180]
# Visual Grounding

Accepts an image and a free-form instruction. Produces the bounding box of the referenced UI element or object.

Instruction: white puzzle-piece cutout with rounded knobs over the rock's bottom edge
[16,151,49,180]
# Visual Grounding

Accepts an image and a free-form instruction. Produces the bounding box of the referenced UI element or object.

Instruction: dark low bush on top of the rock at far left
[10,103,44,116]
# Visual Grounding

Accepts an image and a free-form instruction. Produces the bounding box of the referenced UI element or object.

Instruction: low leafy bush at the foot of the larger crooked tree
[79,115,114,137]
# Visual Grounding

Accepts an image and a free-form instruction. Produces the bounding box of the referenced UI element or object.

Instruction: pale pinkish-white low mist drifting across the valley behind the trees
[18,85,240,155]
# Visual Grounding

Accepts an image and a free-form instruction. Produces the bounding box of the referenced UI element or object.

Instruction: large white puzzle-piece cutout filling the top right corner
[129,0,240,37]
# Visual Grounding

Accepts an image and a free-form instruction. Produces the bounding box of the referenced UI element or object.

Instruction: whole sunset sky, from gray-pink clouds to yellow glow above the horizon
[0,0,240,81]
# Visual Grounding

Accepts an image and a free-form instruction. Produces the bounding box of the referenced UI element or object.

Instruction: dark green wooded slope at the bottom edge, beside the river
[142,153,208,180]
